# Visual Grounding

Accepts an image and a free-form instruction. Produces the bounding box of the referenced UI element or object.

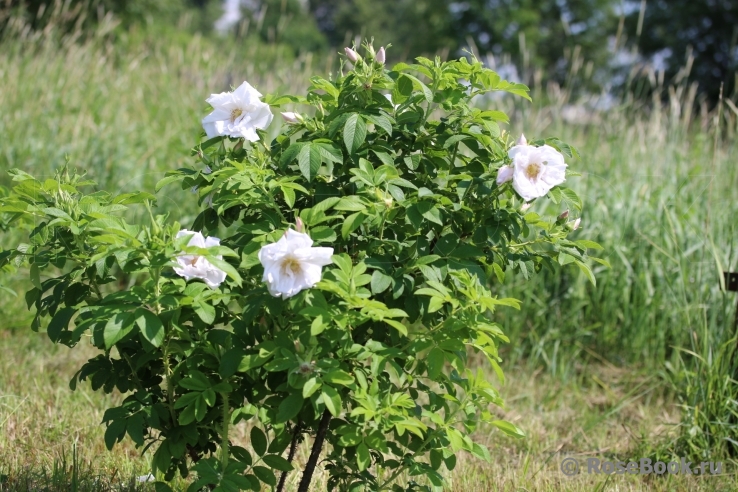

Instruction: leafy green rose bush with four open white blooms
[0,46,602,491]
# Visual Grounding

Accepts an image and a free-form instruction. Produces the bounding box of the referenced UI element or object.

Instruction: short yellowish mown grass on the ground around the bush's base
[0,332,735,492]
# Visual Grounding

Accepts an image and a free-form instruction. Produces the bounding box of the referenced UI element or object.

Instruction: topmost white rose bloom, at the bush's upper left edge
[202,82,274,142]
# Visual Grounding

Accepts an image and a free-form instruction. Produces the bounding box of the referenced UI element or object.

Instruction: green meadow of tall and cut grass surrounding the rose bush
[0,13,738,491]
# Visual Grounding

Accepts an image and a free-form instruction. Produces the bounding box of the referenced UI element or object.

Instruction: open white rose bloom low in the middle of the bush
[259,229,333,299]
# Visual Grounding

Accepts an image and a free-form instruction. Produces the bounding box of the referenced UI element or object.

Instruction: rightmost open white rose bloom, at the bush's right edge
[508,145,566,202]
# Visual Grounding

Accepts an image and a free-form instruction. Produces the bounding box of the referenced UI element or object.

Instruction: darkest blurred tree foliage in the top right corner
[628,0,738,102]
